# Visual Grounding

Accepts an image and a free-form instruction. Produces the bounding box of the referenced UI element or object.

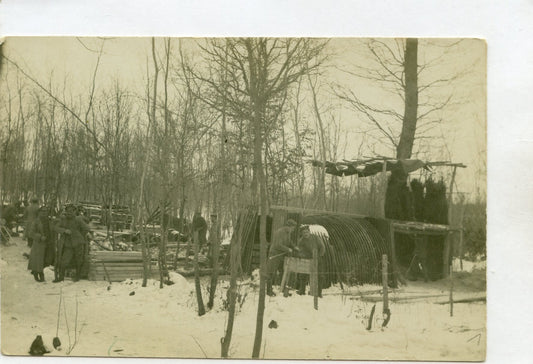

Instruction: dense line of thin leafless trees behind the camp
[0,39,482,240]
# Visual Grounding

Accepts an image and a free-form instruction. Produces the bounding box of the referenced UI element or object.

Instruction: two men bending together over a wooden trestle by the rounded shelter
[267,219,326,297]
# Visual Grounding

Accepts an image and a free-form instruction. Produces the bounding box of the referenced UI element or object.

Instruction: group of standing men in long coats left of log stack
[10,198,91,283]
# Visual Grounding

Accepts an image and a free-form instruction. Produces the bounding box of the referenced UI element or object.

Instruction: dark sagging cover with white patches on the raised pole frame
[311,159,431,177]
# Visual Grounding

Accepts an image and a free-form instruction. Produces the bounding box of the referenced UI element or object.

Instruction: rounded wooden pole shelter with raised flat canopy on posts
[226,158,465,288]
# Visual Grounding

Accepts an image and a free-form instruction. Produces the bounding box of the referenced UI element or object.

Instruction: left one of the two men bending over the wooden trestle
[267,219,296,296]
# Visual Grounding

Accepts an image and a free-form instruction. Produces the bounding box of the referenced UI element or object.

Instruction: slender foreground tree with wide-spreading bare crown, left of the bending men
[191,38,324,358]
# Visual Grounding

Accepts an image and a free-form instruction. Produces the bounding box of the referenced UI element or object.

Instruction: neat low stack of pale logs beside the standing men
[89,251,159,282]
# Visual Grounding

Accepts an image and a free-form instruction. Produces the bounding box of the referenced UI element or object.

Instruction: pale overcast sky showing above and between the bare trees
[4,37,486,198]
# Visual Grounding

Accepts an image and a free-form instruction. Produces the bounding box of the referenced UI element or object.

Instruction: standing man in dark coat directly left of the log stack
[54,205,90,283]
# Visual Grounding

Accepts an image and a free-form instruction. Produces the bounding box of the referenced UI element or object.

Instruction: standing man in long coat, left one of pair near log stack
[28,206,53,282]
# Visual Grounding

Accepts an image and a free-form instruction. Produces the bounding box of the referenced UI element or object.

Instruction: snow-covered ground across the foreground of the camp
[0,238,486,361]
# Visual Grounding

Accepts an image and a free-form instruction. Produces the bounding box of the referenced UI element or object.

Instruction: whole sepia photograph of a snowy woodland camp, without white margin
[0,36,487,361]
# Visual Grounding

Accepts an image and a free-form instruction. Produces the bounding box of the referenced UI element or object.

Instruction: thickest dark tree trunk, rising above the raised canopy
[396,38,418,159]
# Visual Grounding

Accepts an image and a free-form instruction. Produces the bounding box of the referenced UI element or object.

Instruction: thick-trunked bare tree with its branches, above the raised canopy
[335,38,467,159]
